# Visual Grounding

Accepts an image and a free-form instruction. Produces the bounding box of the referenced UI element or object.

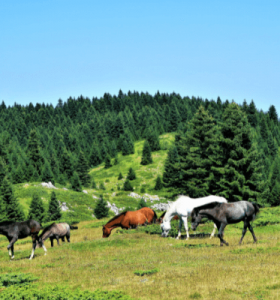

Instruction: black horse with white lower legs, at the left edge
[0,220,47,259]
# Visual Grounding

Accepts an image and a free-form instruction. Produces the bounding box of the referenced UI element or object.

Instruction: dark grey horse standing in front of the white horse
[191,201,260,246]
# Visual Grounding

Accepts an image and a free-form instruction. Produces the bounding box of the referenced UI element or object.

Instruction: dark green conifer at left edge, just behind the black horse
[1,177,25,222]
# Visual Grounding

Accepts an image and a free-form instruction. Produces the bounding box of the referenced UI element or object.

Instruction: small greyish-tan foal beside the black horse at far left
[37,223,78,247]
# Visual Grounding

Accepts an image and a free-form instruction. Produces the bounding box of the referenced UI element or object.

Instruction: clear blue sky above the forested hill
[0,0,280,116]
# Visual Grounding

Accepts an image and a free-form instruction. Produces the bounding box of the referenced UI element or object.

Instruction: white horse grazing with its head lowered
[160,195,227,240]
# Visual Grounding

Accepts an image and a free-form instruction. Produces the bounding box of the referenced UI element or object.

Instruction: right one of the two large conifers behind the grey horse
[218,103,262,201]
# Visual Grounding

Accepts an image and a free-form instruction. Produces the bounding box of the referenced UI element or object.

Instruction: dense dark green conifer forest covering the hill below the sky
[0,91,280,220]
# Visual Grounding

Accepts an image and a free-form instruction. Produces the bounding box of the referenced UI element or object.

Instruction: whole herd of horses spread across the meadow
[0,195,259,259]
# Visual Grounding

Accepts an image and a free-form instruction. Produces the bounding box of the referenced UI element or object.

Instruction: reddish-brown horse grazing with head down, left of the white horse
[103,207,157,238]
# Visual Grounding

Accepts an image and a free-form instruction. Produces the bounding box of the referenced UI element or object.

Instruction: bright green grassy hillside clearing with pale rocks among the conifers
[14,134,174,220]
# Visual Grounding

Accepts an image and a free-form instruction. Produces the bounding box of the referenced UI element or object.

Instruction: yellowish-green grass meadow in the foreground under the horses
[0,220,280,299]
